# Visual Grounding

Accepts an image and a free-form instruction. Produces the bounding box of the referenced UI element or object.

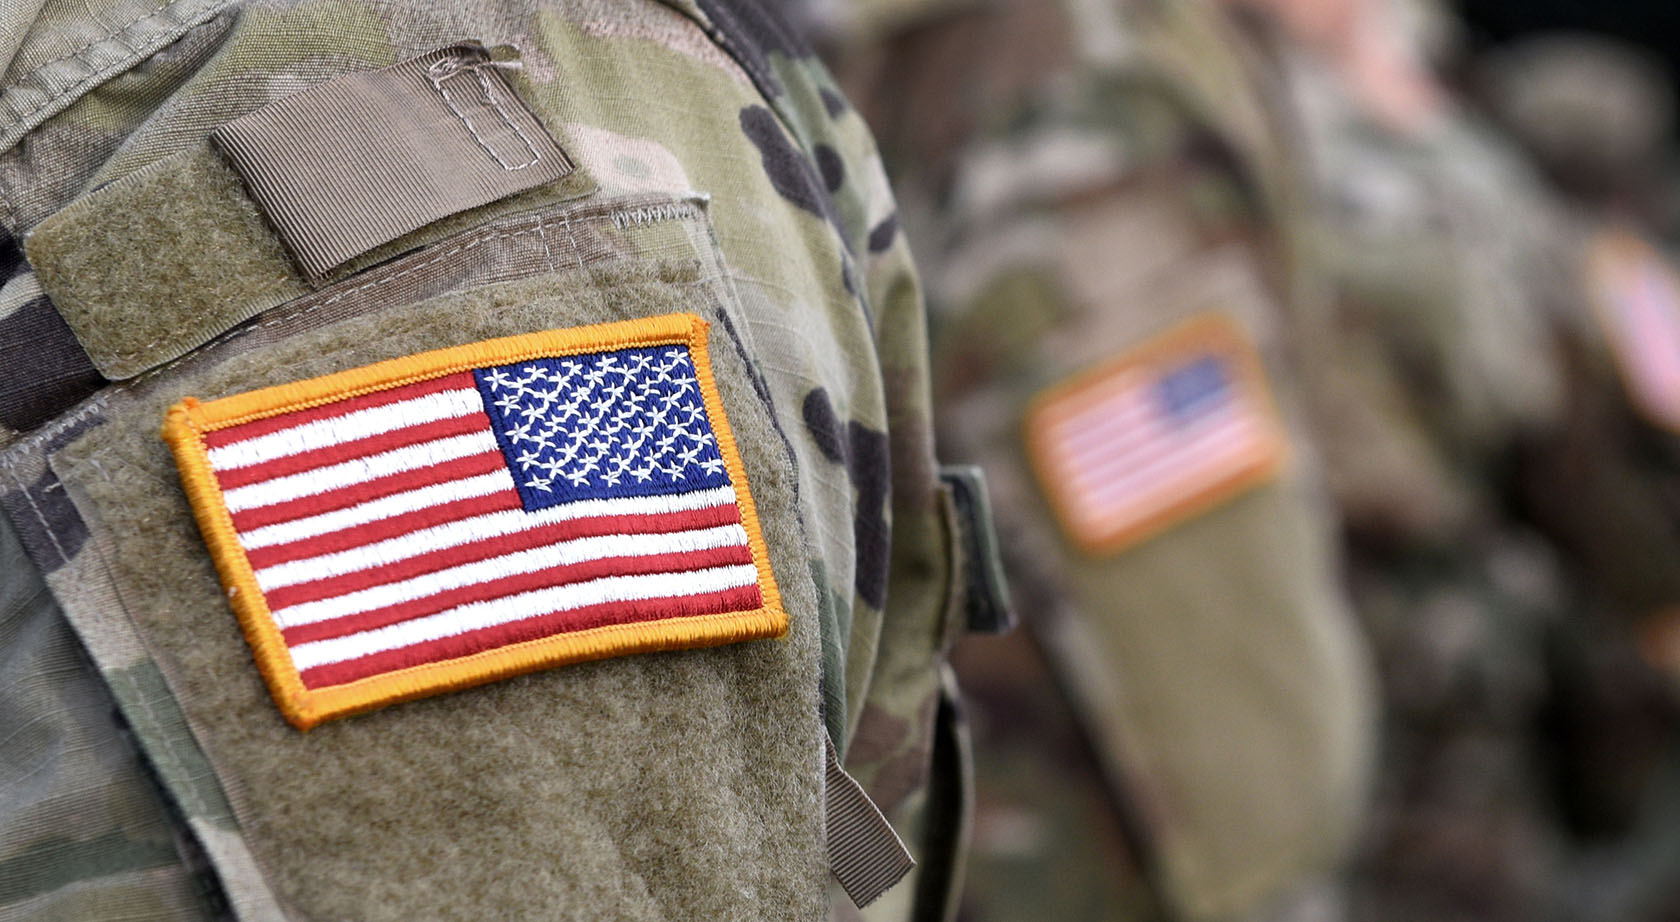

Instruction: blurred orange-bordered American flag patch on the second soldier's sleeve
[1026,314,1285,554]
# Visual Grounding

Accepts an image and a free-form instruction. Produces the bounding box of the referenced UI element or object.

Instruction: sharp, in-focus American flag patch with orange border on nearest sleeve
[165,314,788,729]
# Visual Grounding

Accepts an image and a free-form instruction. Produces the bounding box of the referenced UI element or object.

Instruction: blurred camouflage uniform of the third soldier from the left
[1253,2,1675,919]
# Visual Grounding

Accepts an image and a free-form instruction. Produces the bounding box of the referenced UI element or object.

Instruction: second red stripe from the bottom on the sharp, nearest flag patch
[281,544,753,647]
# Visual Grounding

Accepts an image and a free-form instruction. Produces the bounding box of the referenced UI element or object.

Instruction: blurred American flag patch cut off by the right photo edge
[1593,230,1680,430]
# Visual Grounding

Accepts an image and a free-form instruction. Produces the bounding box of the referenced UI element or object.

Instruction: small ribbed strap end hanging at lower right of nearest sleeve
[823,734,916,909]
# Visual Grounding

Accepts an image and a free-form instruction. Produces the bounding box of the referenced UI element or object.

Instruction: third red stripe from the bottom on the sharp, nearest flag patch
[264,502,741,611]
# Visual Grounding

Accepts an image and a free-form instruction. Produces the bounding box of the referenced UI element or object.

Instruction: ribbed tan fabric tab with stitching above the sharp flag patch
[210,44,573,279]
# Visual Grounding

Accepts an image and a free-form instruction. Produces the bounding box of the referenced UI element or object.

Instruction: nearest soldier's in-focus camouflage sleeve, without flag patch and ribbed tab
[0,0,984,920]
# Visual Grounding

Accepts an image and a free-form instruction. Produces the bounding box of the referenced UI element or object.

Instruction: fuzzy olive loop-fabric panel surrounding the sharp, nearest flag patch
[57,256,827,920]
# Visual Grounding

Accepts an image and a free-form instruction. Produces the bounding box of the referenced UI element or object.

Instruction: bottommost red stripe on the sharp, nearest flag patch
[301,586,763,689]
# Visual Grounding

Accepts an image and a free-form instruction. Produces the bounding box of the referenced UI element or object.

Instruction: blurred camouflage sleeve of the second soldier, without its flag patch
[813,2,1374,920]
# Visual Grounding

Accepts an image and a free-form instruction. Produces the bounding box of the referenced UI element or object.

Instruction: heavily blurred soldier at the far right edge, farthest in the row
[1478,35,1680,919]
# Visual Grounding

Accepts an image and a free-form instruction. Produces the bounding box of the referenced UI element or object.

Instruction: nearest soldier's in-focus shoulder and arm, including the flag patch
[0,0,1001,922]
